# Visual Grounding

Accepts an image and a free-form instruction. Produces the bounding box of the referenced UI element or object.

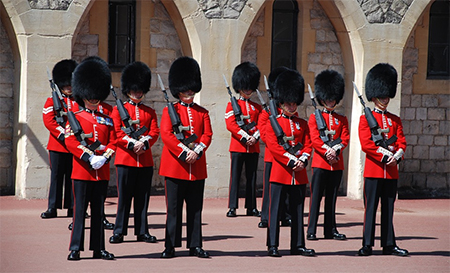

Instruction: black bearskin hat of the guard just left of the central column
[169,56,202,98]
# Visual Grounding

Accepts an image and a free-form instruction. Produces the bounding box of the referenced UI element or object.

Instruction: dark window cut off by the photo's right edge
[427,0,450,79]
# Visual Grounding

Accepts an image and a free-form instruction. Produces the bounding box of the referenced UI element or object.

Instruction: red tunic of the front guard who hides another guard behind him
[265,112,312,185]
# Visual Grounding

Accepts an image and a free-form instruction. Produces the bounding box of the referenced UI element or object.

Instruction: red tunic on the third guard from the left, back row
[111,101,159,167]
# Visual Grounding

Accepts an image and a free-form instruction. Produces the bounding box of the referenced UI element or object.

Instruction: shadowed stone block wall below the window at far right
[399,32,450,197]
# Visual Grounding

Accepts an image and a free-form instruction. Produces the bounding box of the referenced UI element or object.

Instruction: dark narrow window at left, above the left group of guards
[108,0,136,71]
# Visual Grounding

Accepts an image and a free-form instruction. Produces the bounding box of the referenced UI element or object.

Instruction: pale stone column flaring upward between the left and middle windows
[171,0,264,197]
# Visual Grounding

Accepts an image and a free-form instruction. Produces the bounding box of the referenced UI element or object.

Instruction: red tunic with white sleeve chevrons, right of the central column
[225,98,262,153]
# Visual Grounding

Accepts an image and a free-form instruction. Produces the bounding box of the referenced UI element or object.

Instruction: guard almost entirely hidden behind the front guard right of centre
[258,66,291,228]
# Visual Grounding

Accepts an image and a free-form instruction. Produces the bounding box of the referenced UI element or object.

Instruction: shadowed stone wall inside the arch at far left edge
[0,17,14,195]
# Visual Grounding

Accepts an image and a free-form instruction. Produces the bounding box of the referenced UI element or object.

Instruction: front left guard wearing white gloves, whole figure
[66,57,116,260]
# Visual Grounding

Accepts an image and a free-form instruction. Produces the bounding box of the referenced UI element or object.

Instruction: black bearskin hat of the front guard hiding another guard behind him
[275,69,305,105]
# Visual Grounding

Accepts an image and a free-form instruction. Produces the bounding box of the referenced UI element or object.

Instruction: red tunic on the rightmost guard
[359,110,406,179]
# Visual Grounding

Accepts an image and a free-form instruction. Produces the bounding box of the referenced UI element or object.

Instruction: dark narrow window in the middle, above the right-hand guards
[270,0,298,69]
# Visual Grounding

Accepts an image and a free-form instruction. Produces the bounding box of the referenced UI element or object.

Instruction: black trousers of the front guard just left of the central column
[164,177,205,249]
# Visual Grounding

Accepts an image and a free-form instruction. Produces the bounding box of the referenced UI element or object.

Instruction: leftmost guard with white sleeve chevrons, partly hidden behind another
[41,60,78,219]
